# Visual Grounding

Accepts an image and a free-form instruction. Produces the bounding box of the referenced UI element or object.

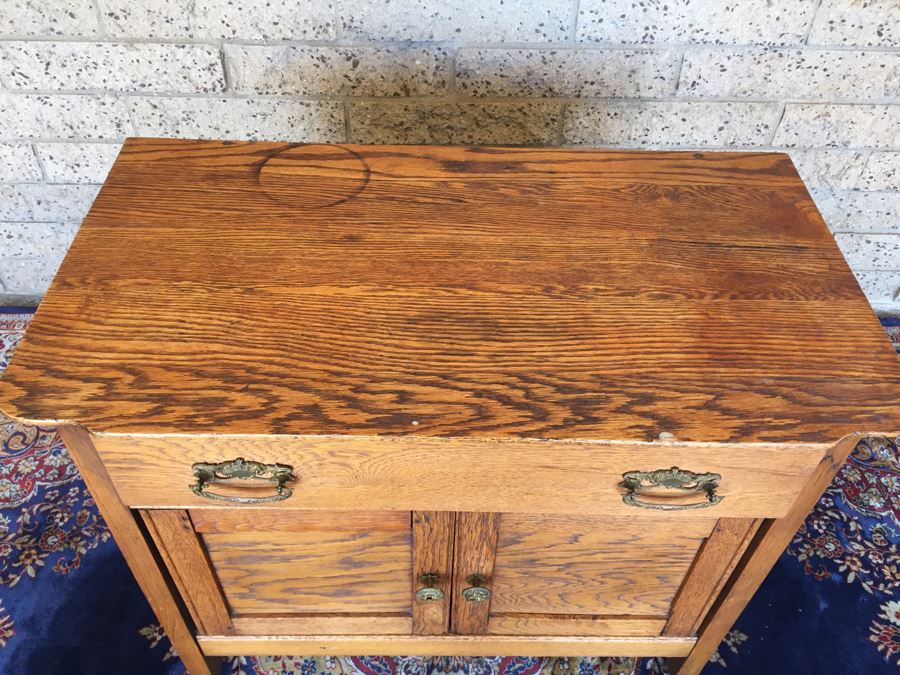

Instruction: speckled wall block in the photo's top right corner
[809,0,900,47]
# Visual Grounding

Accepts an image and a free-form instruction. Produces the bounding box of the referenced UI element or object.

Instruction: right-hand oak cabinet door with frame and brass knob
[452,513,758,637]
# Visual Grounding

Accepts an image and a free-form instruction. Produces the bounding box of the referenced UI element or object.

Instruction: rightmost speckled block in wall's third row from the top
[773,103,900,148]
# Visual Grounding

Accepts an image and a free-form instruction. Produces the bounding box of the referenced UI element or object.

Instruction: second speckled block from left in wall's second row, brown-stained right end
[225,45,450,96]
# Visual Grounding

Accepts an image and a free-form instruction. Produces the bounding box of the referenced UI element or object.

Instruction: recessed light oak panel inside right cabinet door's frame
[491,514,716,618]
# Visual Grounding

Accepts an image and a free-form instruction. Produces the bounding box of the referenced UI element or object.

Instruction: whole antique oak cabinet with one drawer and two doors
[0,139,900,675]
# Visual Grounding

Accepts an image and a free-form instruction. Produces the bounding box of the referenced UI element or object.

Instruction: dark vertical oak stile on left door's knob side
[412,511,456,635]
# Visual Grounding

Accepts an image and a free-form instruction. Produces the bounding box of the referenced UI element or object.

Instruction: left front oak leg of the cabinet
[59,424,221,675]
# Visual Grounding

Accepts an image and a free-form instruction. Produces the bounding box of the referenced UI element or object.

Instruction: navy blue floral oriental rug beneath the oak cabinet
[0,310,900,675]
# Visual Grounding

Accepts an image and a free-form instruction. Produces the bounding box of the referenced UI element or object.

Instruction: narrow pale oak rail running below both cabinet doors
[197,635,696,657]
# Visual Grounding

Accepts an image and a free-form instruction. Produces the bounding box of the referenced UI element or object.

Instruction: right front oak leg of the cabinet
[669,435,861,675]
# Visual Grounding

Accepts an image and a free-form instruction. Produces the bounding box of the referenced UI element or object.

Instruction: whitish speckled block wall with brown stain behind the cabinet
[0,0,900,312]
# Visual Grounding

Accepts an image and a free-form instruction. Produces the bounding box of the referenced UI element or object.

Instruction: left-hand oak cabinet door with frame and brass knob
[142,508,453,635]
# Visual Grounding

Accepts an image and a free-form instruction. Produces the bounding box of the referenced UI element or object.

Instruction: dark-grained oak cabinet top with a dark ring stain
[0,139,900,442]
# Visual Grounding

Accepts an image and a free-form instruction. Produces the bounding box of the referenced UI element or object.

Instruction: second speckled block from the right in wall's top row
[578,0,816,45]
